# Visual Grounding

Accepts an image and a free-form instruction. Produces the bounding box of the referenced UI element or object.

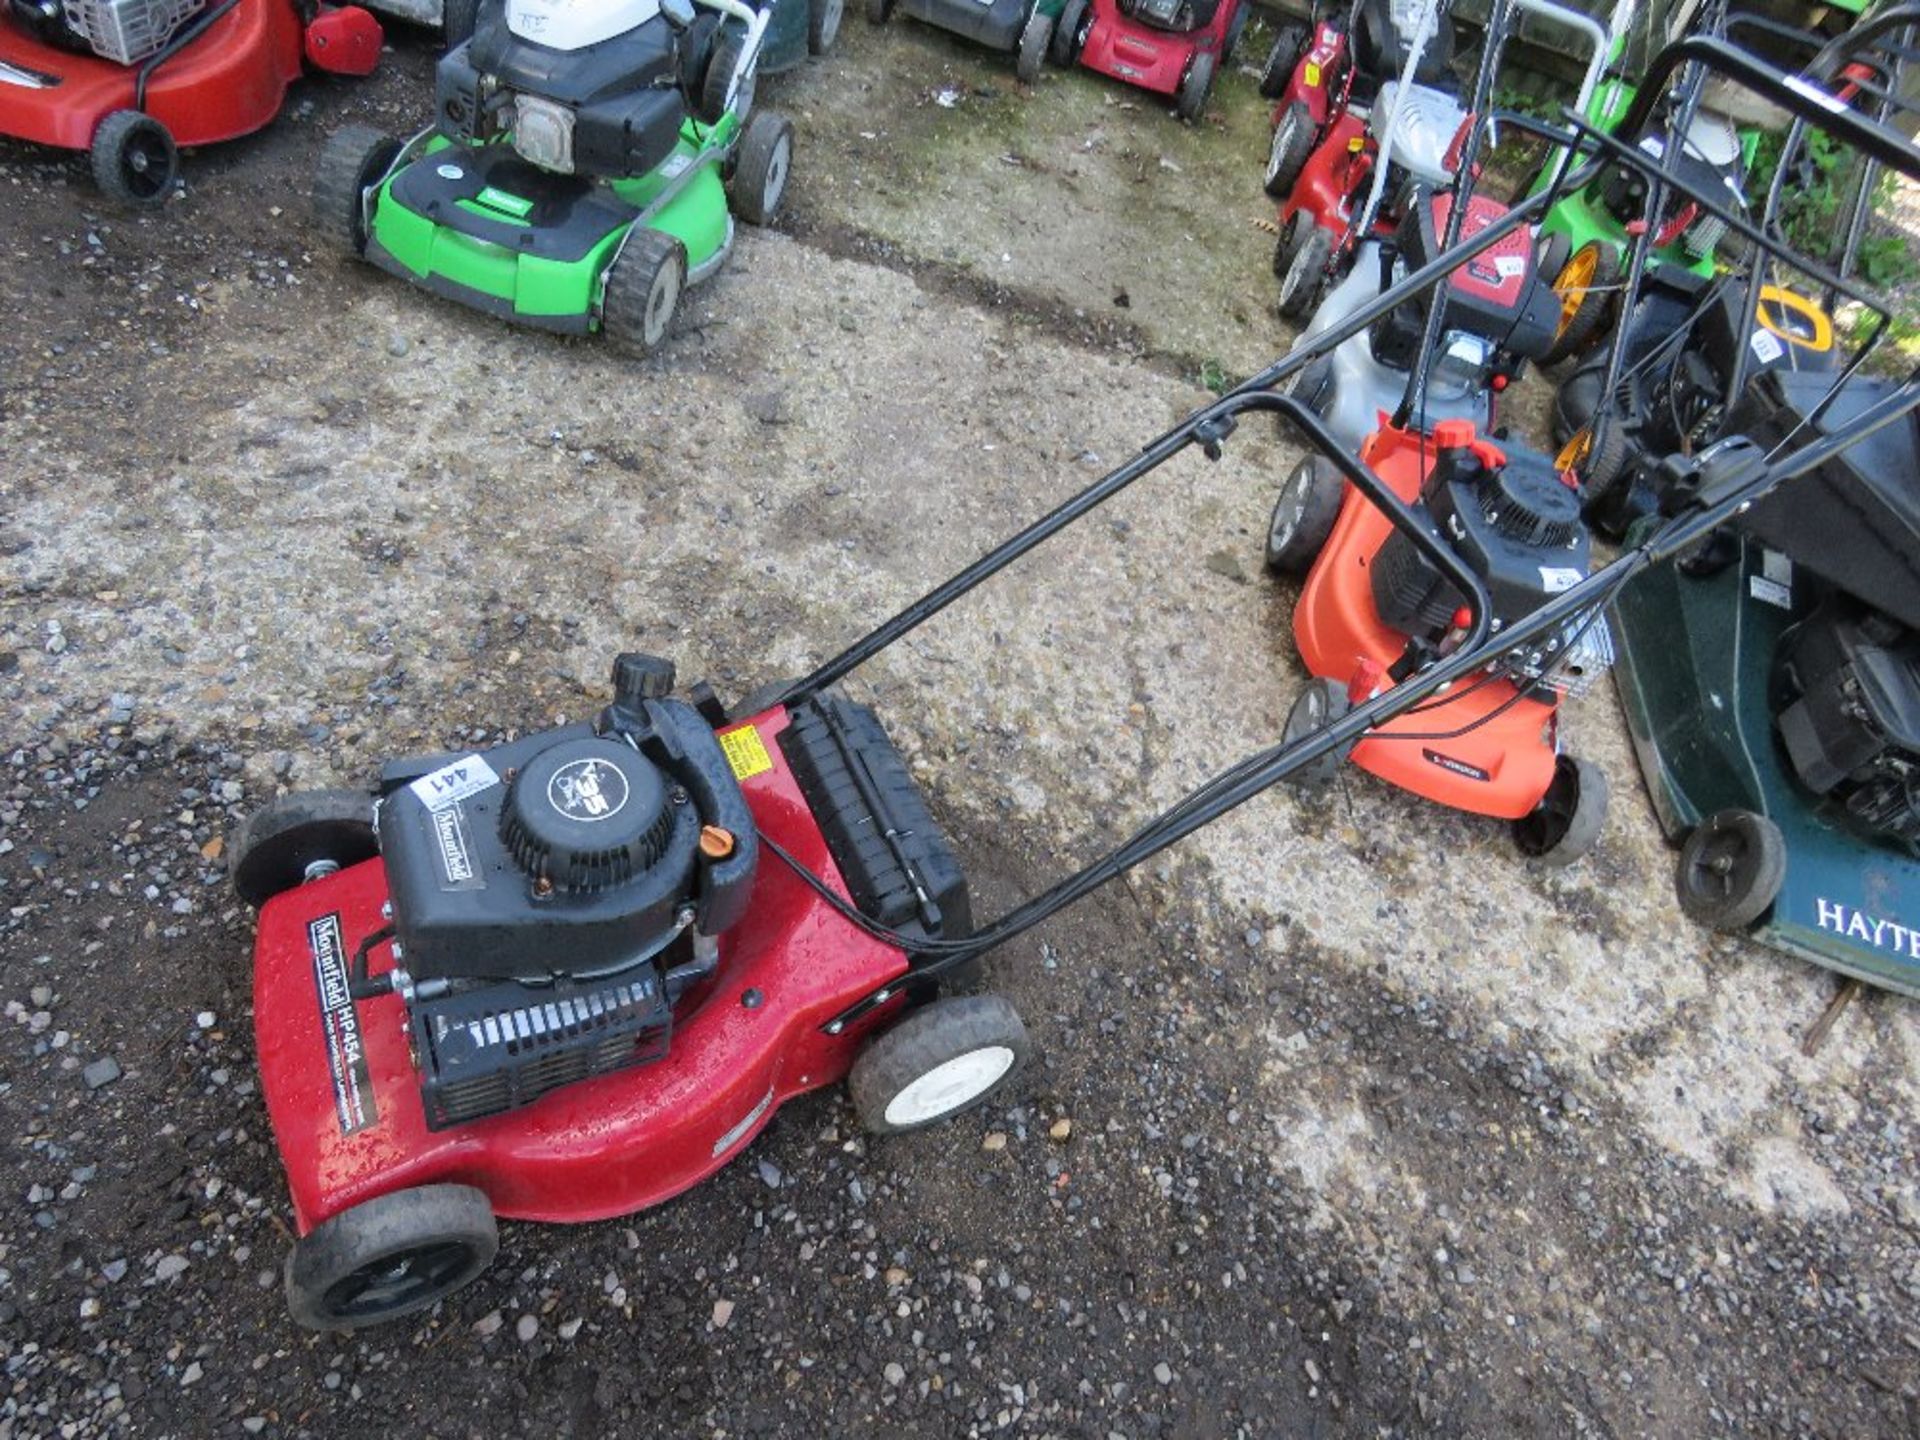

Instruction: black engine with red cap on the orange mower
[1369,420,1613,691]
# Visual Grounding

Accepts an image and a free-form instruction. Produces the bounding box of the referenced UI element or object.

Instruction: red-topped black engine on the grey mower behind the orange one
[1367,186,1559,401]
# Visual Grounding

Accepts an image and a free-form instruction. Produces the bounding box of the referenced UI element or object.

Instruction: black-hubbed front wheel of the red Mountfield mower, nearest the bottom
[286,1185,499,1331]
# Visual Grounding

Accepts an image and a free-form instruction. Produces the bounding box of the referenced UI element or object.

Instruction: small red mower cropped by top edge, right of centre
[1054,0,1246,121]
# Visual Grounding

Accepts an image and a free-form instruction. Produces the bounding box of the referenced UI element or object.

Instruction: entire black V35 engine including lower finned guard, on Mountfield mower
[370,655,758,1129]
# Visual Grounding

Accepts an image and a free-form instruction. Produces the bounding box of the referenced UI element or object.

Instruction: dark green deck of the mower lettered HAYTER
[1613,540,1920,996]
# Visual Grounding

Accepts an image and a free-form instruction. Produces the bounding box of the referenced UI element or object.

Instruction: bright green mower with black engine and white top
[313,0,793,355]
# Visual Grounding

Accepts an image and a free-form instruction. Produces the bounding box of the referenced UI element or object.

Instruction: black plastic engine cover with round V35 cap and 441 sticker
[378,699,758,983]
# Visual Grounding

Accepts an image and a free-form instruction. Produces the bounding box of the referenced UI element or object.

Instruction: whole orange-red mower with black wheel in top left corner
[0,0,382,205]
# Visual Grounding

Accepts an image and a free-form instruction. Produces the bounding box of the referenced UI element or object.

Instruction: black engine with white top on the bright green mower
[436,0,745,179]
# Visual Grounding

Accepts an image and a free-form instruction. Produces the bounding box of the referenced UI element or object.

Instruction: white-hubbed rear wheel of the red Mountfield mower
[847,995,1033,1135]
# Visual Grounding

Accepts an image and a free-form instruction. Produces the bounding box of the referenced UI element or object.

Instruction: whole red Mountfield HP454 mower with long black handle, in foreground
[228,22,1920,1329]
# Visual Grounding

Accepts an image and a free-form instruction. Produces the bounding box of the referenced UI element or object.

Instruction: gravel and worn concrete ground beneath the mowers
[0,21,1920,1440]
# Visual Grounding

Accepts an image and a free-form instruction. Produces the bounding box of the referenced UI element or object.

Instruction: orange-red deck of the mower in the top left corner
[0,0,303,150]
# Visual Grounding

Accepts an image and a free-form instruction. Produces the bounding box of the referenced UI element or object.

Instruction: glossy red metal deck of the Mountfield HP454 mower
[253,708,906,1235]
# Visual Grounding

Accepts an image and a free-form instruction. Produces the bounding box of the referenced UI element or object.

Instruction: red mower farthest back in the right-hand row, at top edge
[1260,0,1453,203]
